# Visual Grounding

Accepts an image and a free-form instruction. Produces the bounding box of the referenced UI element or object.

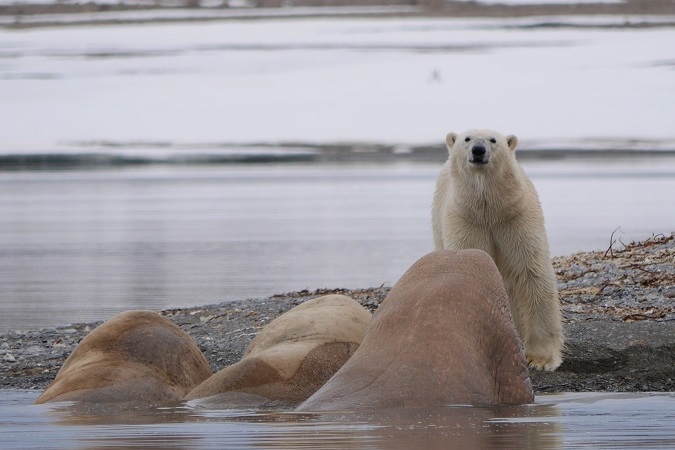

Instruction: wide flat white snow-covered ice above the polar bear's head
[0,17,675,153]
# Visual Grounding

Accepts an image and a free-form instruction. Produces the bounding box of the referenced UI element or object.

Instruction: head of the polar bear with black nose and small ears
[445,130,518,169]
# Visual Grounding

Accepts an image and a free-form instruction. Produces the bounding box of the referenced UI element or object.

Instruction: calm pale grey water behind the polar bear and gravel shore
[0,158,675,332]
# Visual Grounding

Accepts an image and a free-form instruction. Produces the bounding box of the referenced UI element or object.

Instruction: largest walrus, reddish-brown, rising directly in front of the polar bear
[297,250,534,411]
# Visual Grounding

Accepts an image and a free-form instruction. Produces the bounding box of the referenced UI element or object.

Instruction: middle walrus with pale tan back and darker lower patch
[184,295,371,407]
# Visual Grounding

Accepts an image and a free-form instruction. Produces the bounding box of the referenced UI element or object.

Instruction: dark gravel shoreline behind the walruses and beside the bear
[0,233,675,392]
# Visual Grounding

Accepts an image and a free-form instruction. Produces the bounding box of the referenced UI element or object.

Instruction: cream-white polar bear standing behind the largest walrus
[431,130,564,370]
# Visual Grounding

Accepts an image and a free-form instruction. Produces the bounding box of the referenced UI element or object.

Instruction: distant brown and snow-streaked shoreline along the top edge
[0,0,675,28]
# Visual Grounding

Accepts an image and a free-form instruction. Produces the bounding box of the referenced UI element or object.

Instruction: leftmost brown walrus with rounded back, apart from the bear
[35,310,212,404]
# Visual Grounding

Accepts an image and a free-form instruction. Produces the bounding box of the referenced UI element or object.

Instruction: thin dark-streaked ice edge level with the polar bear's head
[0,143,675,172]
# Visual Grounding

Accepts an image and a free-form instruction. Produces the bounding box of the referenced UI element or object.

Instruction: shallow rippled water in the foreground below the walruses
[0,390,675,450]
